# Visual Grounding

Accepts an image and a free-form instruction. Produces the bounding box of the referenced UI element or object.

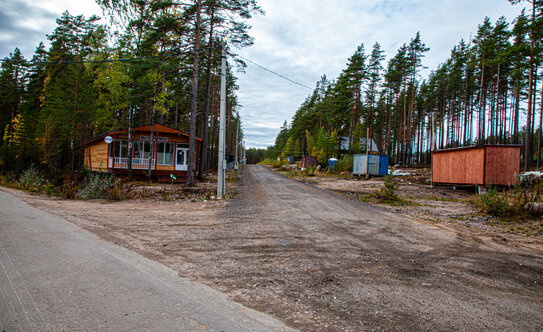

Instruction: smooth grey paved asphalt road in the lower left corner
[0,190,296,331]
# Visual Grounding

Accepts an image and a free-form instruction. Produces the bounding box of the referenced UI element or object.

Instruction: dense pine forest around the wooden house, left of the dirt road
[0,0,263,183]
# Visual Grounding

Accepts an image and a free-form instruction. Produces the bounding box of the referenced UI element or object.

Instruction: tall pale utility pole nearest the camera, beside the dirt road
[217,40,226,199]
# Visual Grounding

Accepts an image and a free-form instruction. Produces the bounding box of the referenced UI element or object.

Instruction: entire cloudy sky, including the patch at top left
[0,0,523,148]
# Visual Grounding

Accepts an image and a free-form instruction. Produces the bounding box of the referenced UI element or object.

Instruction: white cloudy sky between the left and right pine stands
[235,0,521,146]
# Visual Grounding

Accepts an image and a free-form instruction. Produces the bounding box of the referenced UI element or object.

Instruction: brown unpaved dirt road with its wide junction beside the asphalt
[5,166,543,331]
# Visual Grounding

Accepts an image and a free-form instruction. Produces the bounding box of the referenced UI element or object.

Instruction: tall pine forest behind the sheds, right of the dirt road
[254,1,543,170]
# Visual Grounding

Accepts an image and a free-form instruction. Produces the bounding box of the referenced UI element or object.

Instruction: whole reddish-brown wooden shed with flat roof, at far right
[432,144,521,186]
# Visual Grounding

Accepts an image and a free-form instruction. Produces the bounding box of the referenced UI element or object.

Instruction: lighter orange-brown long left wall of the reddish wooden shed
[432,147,485,184]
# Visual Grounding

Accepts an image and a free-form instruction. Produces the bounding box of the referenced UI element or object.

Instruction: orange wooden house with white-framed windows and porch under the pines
[85,124,202,182]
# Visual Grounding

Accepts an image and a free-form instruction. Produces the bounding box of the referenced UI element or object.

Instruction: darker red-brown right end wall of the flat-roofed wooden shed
[485,146,521,185]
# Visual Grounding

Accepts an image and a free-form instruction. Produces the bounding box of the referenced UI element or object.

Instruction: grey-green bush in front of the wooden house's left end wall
[77,173,121,200]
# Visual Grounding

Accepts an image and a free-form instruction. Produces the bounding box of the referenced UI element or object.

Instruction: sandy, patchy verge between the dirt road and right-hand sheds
[280,168,543,238]
